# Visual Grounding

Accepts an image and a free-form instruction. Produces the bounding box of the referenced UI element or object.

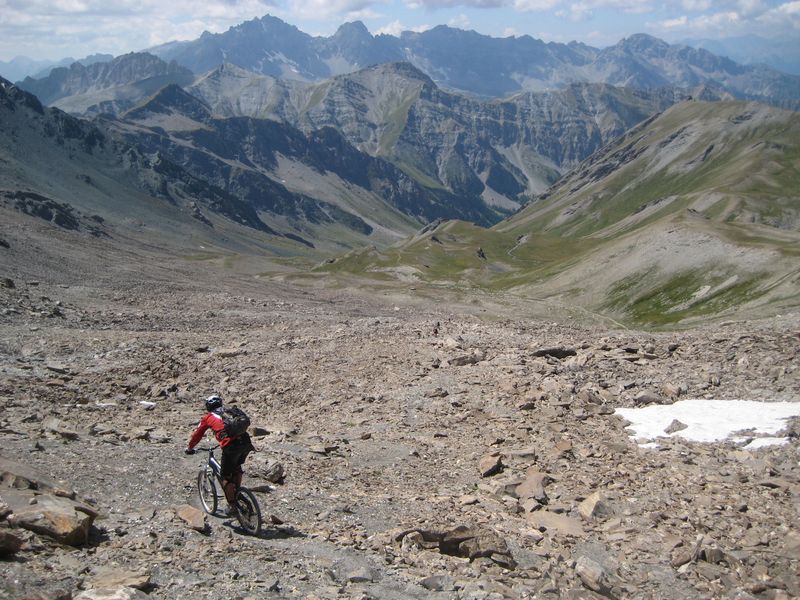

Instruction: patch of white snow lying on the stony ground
[616,400,800,449]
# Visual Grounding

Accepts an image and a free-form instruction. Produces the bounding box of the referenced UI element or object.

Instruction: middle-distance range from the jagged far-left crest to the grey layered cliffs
[15,54,696,224]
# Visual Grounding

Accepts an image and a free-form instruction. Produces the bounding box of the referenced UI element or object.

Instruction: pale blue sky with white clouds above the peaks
[0,0,800,61]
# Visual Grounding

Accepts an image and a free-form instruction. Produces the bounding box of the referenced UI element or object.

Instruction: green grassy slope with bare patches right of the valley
[318,102,800,327]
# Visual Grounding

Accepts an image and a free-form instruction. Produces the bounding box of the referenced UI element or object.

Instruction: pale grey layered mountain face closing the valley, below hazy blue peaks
[189,63,688,205]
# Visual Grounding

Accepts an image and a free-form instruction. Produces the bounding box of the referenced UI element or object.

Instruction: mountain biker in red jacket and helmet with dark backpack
[185,394,255,506]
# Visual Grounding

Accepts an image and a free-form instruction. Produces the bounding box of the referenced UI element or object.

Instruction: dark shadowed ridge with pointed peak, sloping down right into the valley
[119,86,495,230]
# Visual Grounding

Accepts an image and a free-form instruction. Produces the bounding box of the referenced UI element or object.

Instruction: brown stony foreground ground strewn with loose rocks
[0,264,800,599]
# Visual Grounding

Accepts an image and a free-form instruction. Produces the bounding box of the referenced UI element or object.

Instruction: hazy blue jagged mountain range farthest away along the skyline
[145,15,800,109]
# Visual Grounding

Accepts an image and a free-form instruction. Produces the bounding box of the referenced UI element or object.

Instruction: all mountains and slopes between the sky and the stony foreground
[0,12,800,326]
